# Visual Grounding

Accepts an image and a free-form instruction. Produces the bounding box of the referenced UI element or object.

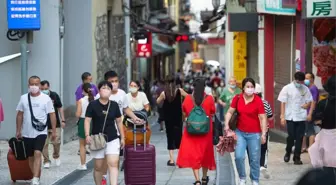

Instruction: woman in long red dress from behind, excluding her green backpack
[177,79,216,185]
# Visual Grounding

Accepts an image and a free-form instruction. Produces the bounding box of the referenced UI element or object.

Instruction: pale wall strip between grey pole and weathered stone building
[63,0,94,107]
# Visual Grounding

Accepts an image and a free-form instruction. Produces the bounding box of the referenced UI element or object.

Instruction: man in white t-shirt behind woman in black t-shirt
[96,71,142,185]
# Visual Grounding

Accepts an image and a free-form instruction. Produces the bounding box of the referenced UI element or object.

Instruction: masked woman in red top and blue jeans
[224,78,267,185]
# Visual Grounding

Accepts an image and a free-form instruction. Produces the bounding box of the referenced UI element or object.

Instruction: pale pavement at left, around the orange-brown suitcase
[0,140,91,185]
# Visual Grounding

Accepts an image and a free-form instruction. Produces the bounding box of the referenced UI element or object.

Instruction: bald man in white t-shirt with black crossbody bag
[16,76,56,185]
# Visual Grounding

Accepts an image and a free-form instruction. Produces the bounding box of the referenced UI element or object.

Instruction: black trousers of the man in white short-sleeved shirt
[286,120,306,160]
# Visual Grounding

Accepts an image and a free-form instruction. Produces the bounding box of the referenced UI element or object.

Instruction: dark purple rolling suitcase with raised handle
[124,125,156,185]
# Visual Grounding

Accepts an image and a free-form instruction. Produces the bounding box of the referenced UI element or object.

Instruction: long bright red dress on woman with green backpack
[177,95,216,170]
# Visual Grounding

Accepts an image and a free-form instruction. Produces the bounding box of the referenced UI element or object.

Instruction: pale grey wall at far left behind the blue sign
[0,0,60,139]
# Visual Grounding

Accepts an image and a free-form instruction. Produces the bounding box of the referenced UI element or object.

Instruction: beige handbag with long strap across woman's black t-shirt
[90,102,111,151]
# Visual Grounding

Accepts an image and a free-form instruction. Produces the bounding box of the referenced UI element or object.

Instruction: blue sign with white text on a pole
[7,0,41,30]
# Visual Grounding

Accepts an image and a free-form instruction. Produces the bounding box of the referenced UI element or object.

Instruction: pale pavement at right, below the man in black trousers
[231,142,312,185]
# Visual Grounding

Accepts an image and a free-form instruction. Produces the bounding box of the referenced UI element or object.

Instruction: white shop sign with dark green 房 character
[306,0,336,18]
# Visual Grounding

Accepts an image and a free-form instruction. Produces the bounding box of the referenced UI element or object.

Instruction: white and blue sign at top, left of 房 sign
[257,0,296,15]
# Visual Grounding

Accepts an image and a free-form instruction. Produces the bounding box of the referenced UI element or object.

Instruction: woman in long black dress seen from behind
[157,76,183,166]
